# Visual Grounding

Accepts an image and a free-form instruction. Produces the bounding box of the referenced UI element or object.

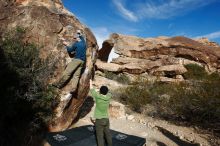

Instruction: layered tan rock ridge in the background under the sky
[96,34,220,81]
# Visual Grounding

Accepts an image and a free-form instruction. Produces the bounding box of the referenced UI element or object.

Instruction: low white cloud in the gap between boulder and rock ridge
[92,27,111,48]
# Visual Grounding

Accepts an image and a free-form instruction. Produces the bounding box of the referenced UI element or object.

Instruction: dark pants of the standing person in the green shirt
[95,118,112,146]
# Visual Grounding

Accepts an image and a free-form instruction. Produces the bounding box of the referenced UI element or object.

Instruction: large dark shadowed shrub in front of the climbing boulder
[0,27,57,146]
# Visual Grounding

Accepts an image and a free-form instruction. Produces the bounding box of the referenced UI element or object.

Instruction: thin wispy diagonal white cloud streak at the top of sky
[113,0,138,22]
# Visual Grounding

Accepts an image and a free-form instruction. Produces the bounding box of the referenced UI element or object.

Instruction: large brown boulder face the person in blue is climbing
[0,0,97,131]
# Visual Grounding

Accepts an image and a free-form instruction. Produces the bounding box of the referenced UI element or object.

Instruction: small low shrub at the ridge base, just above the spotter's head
[104,71,130,84]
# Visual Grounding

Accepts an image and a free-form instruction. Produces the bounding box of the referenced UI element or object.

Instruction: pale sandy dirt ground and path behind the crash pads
[74,100,211,146]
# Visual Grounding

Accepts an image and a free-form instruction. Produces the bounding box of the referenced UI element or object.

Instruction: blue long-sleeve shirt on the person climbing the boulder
[66,36,86,61]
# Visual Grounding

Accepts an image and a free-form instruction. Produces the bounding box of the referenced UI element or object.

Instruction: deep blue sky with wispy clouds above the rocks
[62,0,220,44]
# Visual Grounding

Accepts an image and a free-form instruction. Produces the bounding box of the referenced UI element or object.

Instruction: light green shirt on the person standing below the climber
[90,89,111,119]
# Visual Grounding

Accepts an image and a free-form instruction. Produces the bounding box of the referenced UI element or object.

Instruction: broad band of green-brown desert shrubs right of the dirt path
[117,73,220,130]
